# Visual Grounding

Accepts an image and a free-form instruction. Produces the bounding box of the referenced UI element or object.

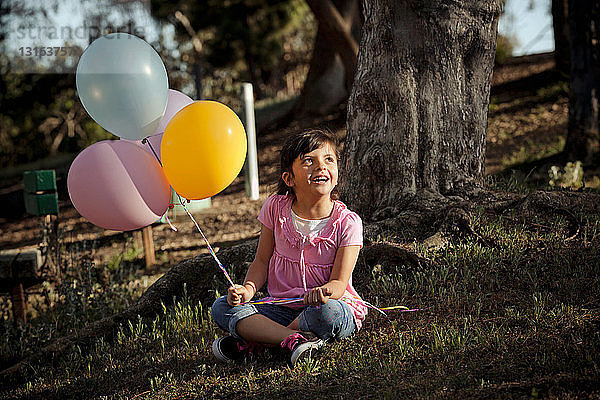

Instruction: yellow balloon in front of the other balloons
[160,100,247,200]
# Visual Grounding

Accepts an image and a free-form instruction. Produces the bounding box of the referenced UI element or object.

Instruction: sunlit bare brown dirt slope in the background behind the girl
[0,54,567,273]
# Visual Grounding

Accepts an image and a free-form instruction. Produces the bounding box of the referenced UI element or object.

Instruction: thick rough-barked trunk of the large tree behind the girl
[342,0,501,218]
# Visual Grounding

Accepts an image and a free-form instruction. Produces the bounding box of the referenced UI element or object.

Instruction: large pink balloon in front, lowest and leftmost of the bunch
[67,140,171,231]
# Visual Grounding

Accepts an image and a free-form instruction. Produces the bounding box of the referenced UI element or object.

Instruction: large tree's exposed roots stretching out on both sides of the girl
[0,191,600,382]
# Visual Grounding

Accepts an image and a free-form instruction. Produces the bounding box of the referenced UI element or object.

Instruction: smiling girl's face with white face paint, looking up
[282,143,338,202]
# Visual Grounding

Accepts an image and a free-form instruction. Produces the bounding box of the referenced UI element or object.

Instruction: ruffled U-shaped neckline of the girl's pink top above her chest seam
[279,195,346,248]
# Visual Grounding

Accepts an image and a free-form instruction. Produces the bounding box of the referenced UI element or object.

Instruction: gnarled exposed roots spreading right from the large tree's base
[365,190,600,247]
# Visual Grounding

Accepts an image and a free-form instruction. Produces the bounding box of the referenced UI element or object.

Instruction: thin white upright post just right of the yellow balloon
[242,82,258,200]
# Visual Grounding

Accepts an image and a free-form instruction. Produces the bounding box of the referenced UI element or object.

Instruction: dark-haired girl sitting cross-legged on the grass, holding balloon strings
[212,130,367,366]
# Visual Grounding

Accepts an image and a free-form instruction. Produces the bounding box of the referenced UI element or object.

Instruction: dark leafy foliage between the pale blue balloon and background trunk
[151,0,308,99]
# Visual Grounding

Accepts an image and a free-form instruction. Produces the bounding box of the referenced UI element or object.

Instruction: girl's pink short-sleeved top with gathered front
[258,194,367,329]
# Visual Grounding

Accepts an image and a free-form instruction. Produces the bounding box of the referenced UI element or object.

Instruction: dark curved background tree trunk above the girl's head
[293,0,361,115]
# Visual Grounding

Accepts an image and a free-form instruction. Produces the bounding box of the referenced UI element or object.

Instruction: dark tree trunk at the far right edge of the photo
[564,0,600,165]
